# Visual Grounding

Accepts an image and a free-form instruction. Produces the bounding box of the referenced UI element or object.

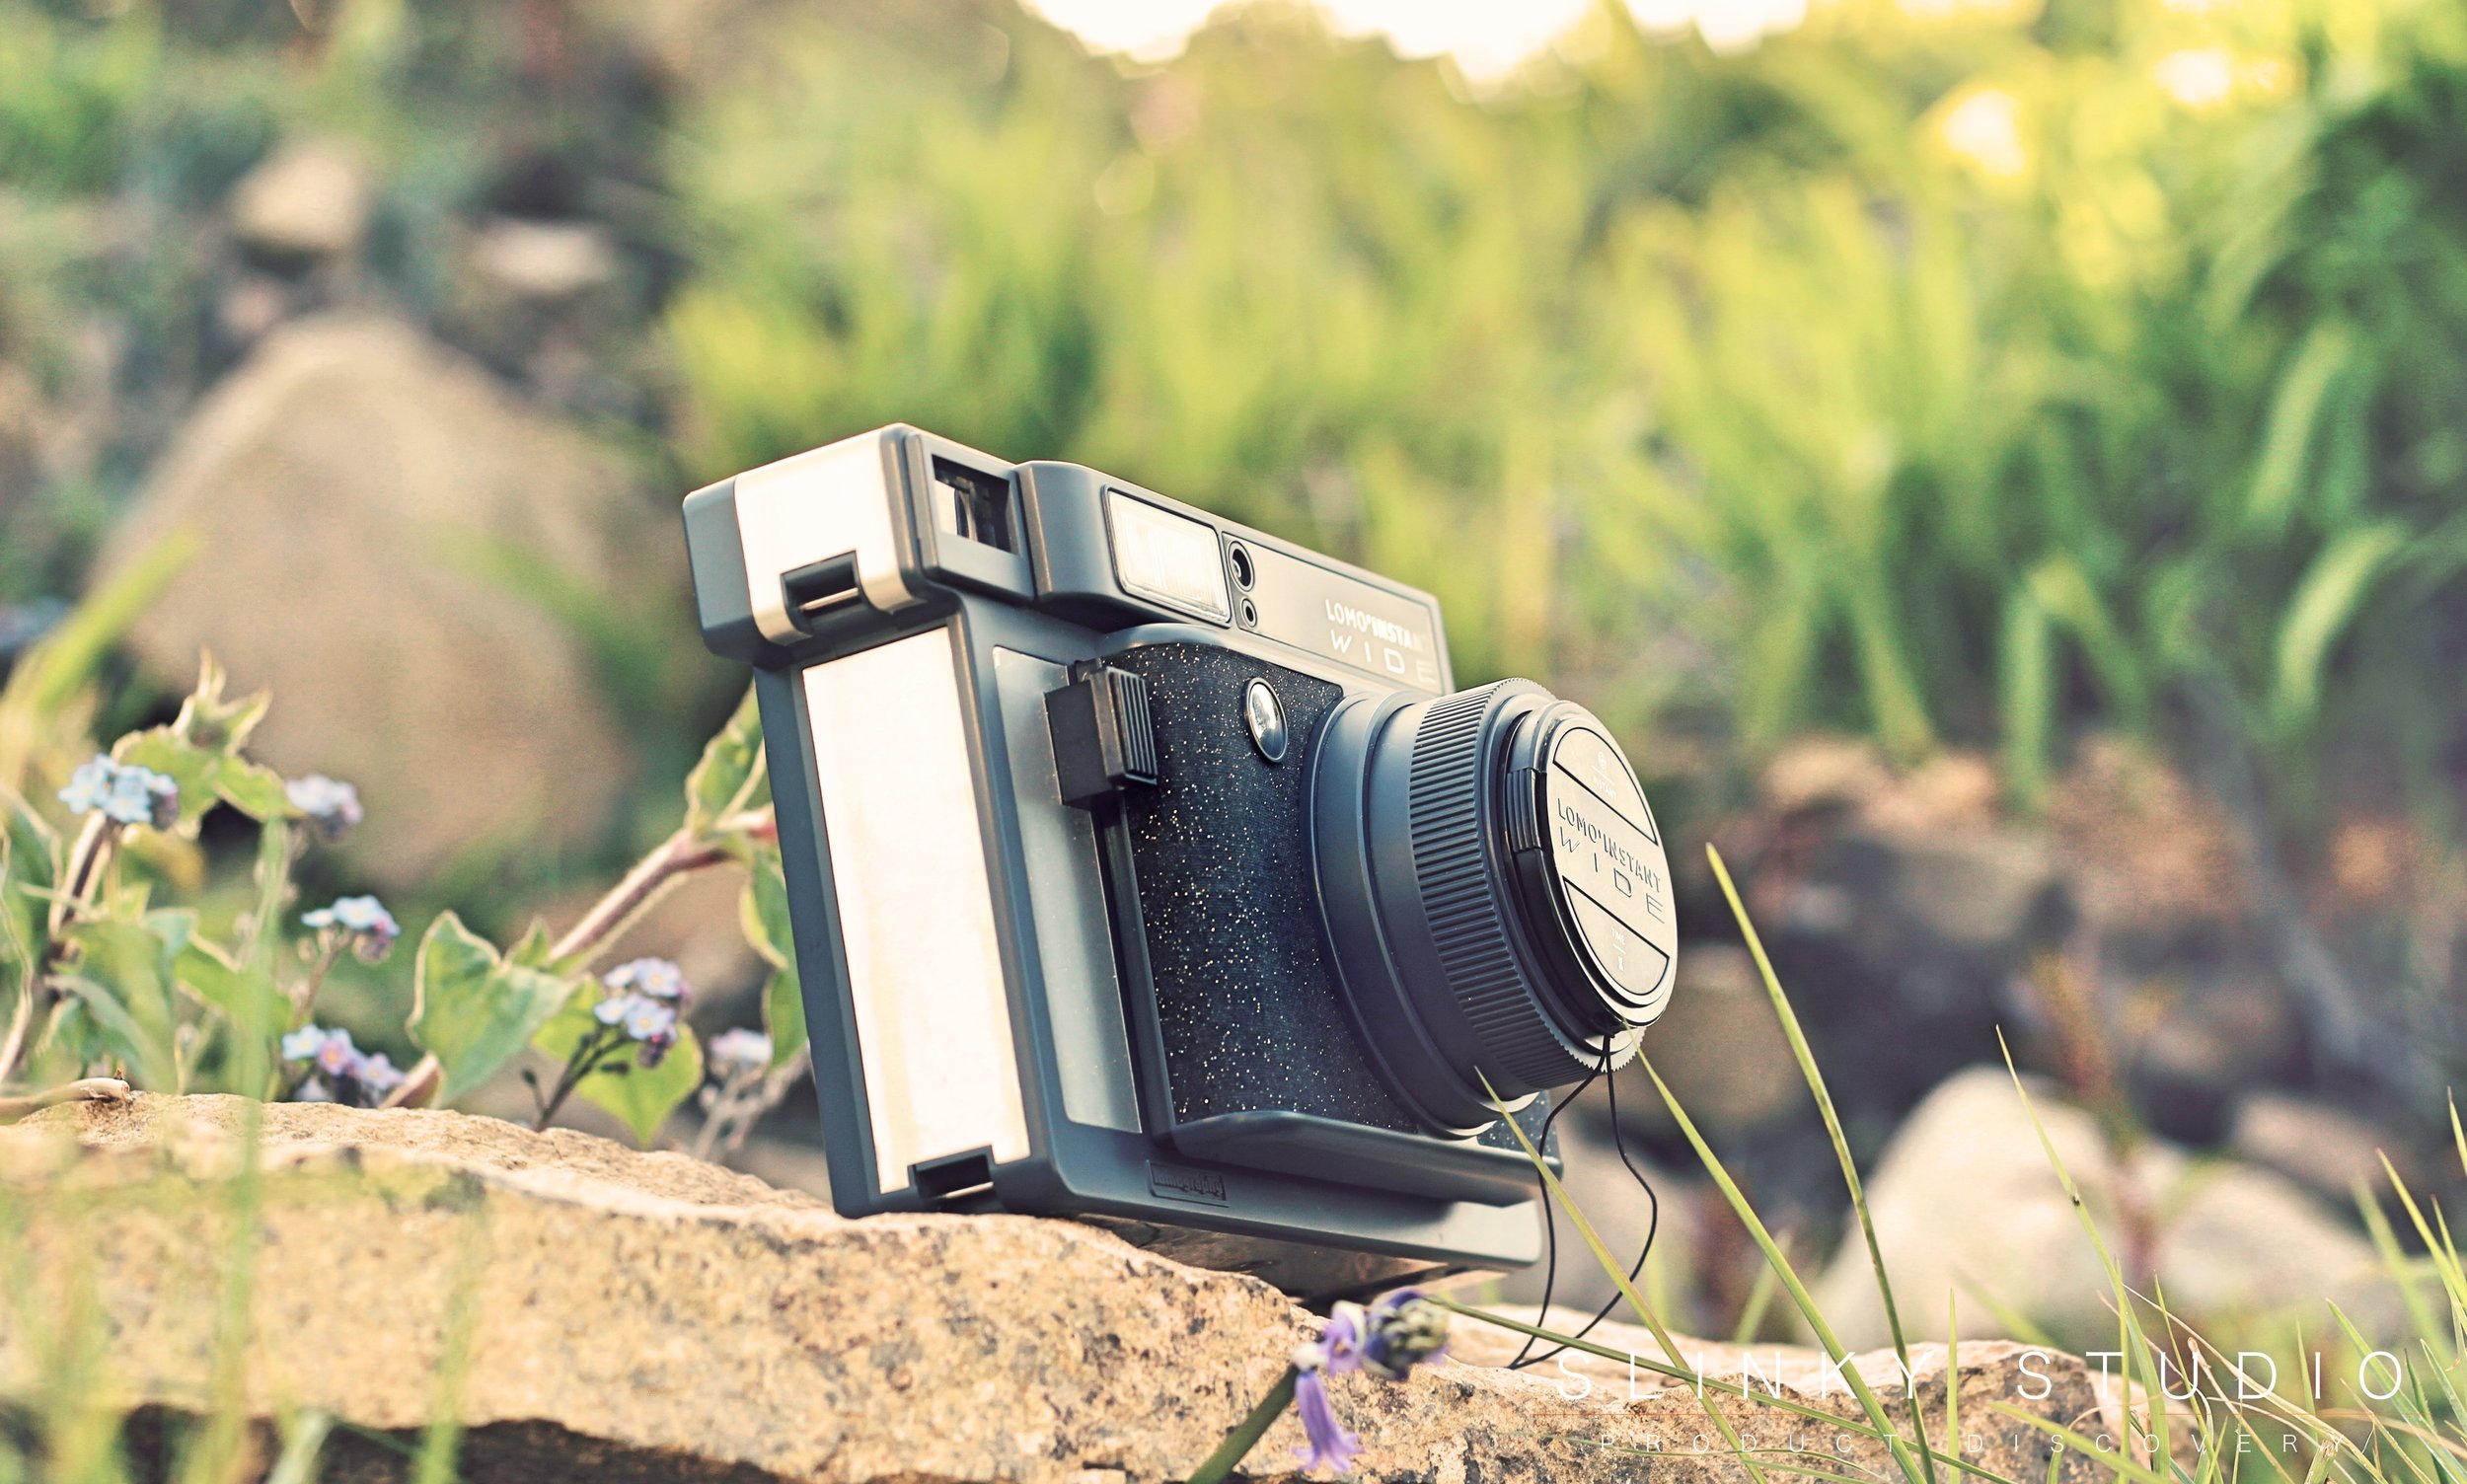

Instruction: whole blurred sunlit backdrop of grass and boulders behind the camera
[0,0,2467,1371]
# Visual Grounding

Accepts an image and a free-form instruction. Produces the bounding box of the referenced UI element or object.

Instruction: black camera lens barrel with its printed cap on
[1312,681,1678,1134]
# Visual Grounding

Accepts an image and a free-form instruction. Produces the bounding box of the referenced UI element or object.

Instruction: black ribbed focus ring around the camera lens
[1406,681,1579,1097]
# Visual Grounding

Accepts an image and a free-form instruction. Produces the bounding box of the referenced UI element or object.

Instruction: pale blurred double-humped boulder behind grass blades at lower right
[1814,1068,2398,1349]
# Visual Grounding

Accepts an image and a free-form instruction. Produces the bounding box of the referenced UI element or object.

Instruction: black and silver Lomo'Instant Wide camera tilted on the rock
[686,426,1678,1295]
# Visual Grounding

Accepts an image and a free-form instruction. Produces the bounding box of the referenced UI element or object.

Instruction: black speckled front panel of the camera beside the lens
[1110,643,1547,1149]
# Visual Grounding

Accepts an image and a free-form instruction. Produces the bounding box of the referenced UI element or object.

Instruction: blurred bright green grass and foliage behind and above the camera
[669,0,2467,838]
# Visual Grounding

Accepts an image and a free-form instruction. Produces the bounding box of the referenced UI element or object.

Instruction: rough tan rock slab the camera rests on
[0,1097,2100,1484]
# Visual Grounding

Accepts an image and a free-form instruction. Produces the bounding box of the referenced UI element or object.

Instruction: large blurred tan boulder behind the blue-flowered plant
[104,318,679,890]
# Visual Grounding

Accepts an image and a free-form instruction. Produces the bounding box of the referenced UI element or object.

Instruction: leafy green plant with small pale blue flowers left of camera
[0,635,804,1144]
